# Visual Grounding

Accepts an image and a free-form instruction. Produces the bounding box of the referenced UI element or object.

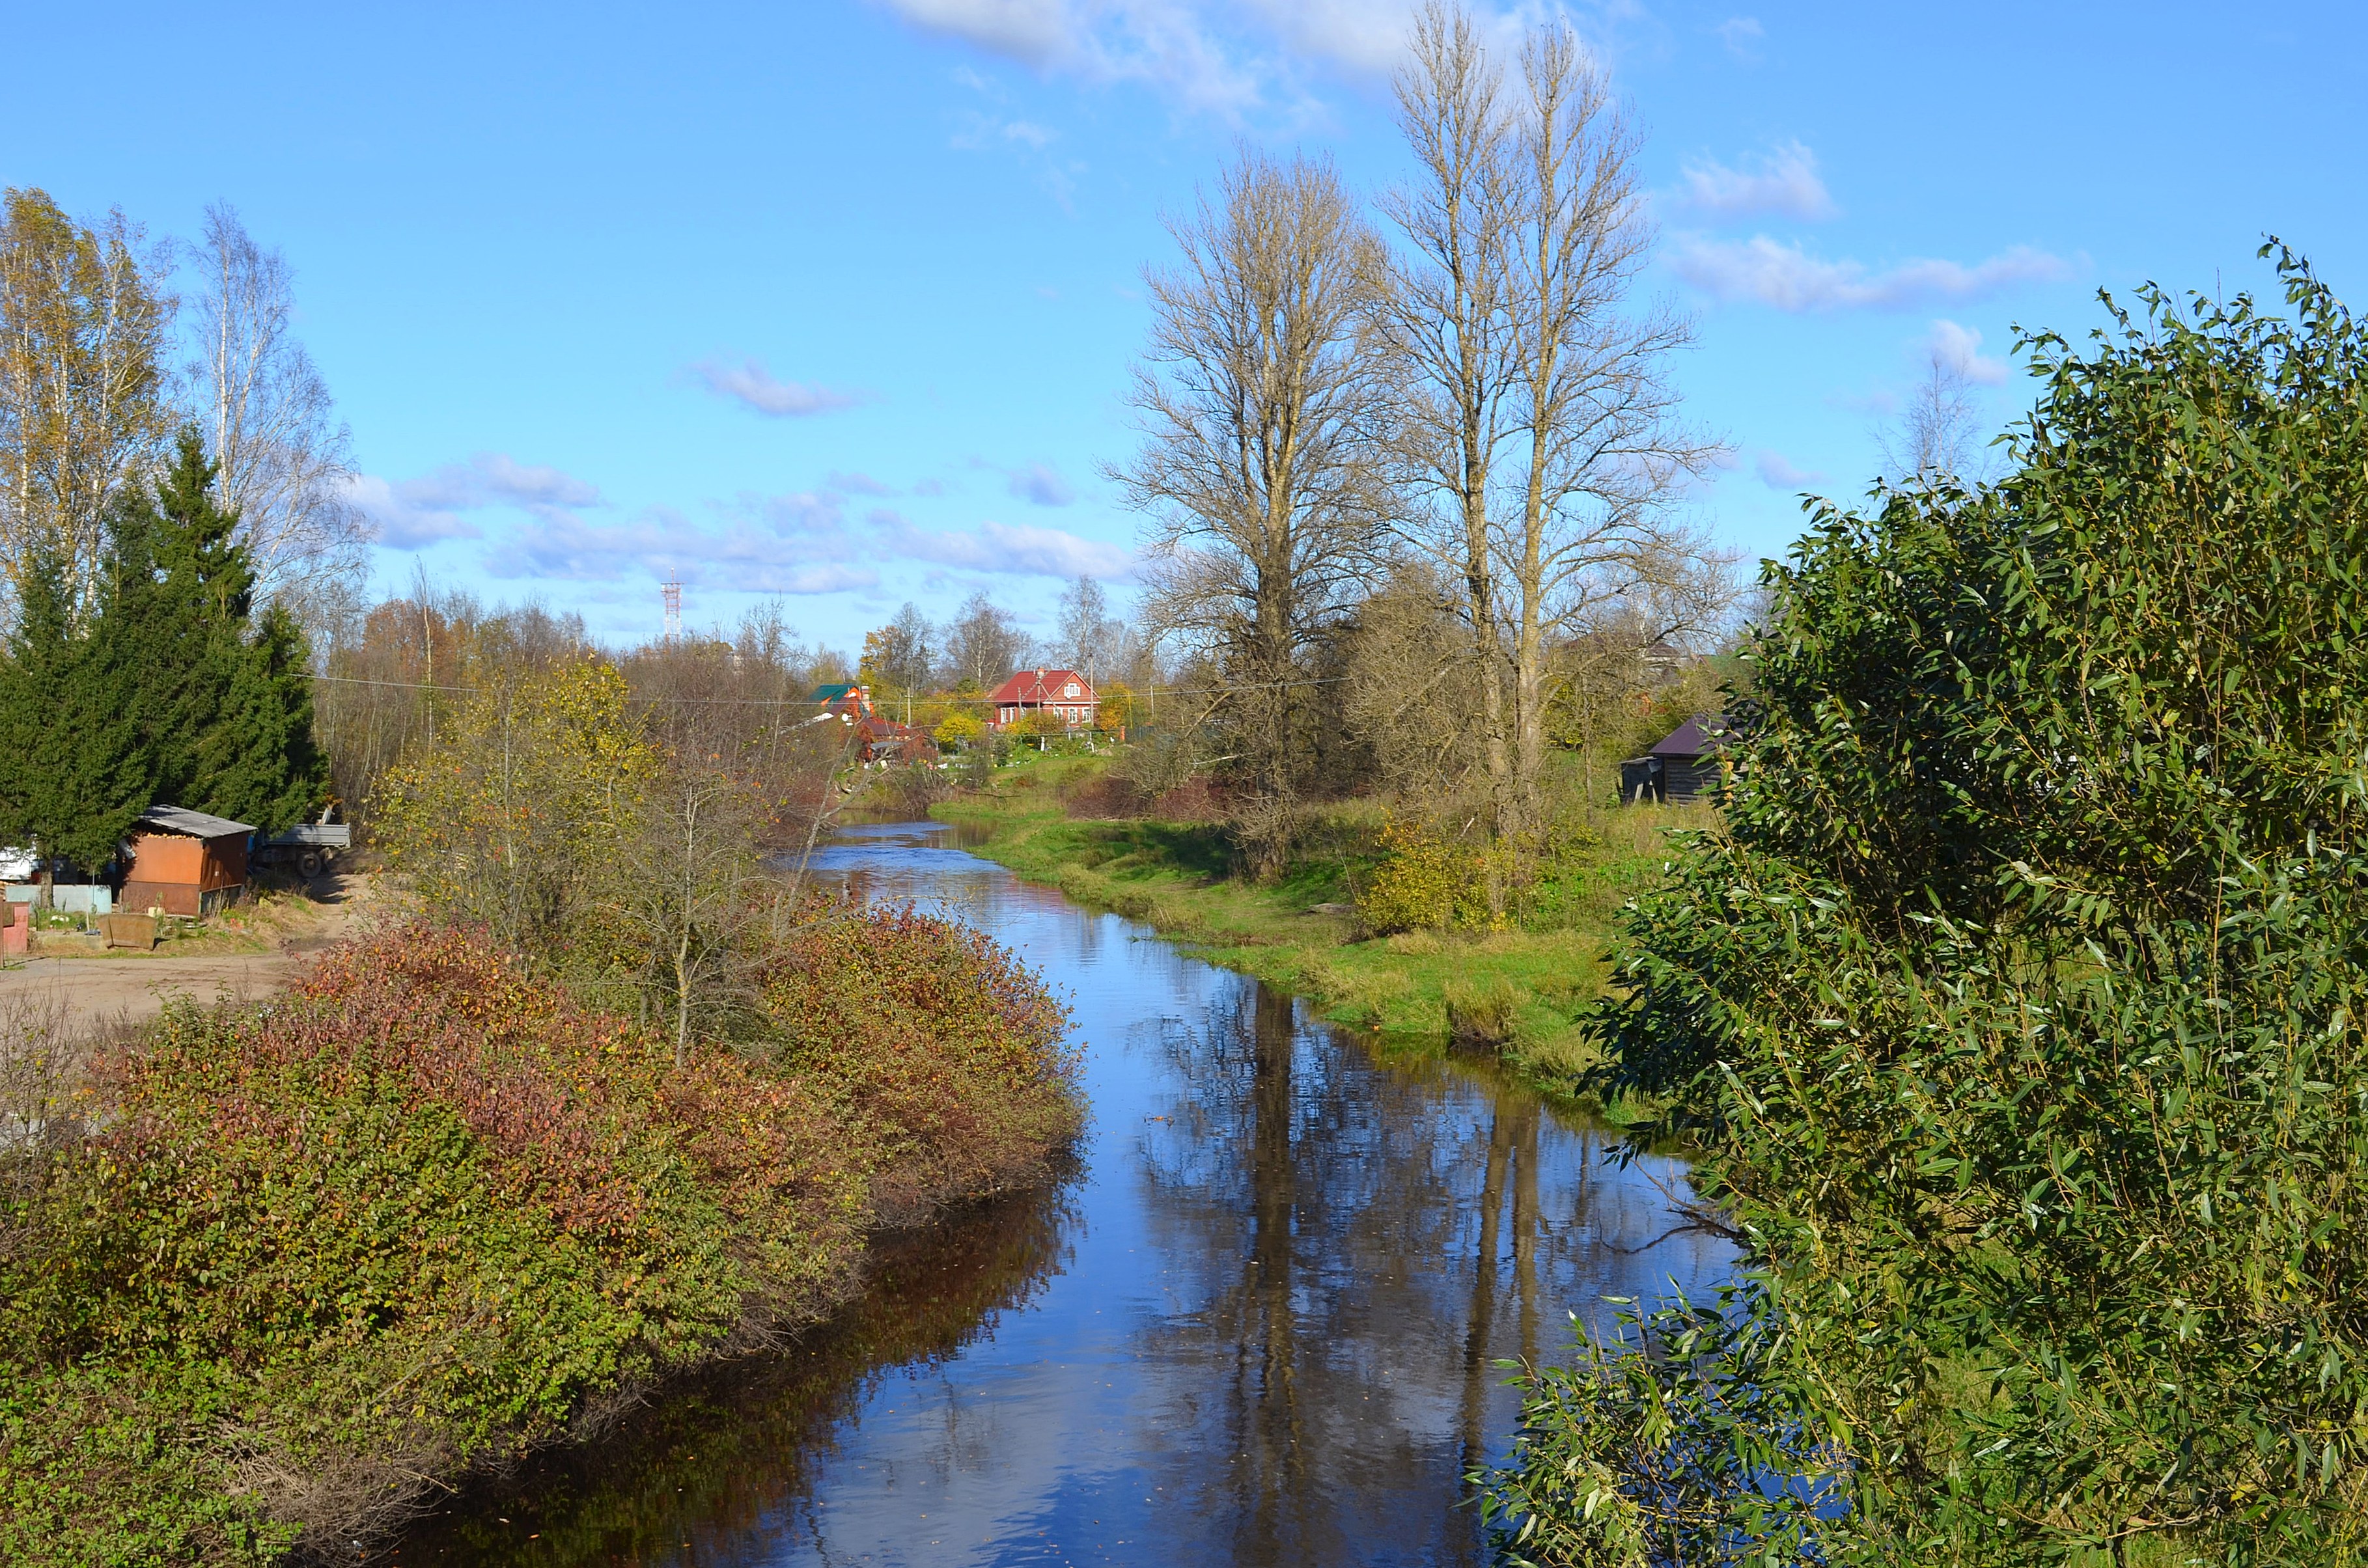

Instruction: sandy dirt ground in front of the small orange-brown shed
[0,872,395,1042]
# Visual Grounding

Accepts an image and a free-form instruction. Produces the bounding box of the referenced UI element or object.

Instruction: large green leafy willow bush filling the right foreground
[1487,258,2368,1563]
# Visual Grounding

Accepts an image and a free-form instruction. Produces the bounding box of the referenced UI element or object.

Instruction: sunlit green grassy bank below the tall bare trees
[930,758,1710,1090]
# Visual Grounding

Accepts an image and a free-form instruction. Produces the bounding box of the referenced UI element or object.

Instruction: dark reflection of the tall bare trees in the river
[1139,983,1724,1563]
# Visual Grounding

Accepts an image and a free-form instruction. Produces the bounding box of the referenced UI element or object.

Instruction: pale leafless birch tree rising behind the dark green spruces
[192,204,369,597]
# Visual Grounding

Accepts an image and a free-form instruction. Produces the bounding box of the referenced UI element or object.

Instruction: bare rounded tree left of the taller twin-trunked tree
[1111,152,1386,874]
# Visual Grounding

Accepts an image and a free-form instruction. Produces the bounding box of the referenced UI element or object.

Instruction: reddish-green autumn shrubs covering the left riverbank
[0,912,1082,1568]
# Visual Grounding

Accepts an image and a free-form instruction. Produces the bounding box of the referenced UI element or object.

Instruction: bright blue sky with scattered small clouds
[0,0,2368,649]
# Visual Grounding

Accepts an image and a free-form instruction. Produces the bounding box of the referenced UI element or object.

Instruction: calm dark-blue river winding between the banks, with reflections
[393,824,1731,1568]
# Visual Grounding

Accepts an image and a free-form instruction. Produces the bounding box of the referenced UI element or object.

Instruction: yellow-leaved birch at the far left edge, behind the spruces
[0,189,173,616]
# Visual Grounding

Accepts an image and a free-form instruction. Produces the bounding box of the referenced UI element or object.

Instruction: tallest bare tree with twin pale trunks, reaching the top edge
[1383,0,1724,885]
